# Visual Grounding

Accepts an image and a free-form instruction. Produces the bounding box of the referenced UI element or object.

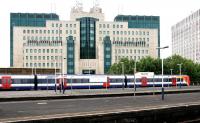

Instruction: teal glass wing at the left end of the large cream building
[10,13,59,67]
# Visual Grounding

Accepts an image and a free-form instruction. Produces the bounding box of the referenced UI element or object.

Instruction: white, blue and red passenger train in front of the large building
[0,72,190,90]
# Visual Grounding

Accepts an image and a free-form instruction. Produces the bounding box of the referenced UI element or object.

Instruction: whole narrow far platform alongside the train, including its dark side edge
[0,86,200,102]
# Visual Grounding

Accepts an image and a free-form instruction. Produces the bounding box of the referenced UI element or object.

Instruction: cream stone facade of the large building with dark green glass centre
[13,6,160,74]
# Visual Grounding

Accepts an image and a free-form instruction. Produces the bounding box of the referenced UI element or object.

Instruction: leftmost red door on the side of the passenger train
[1,76,12,89]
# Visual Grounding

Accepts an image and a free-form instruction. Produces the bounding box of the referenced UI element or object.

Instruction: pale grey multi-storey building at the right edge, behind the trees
[171,10,200,63]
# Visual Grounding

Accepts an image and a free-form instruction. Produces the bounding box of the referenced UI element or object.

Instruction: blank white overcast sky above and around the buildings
[0,0,200,67]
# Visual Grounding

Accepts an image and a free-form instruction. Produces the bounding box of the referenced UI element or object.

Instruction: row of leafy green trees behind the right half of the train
[108,55,200,82]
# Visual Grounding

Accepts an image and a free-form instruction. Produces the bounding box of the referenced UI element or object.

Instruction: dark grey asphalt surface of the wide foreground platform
[0,93,200,122]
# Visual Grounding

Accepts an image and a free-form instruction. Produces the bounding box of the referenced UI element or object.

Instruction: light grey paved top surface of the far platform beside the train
[0,86,200,100]
